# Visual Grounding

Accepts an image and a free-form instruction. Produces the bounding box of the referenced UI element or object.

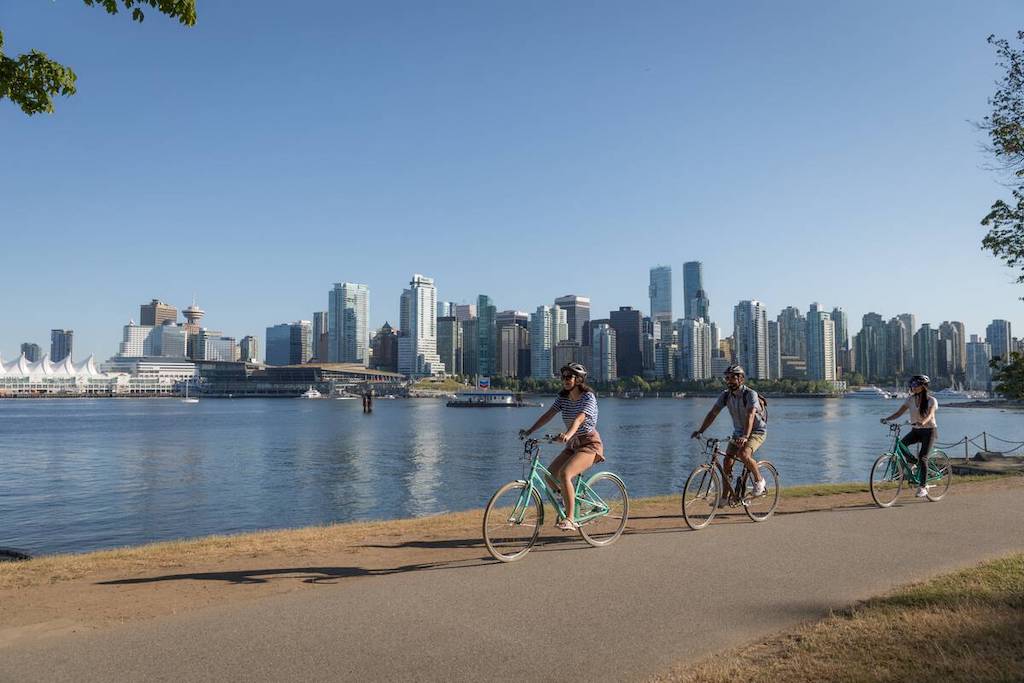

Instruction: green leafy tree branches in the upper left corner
[0,0,196,116]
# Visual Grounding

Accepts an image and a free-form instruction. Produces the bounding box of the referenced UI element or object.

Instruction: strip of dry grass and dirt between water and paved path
[0,477,1024,648]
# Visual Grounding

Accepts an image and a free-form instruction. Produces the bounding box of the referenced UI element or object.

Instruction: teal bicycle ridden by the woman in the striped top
[483,435,630,562]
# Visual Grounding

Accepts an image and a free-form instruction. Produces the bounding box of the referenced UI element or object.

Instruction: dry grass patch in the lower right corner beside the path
[653,553,1024,683]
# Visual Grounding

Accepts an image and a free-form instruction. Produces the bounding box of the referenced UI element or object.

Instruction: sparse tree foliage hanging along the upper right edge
[980,31,1024,284]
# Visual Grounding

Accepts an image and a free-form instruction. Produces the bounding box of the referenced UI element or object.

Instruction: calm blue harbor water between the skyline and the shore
[0,397,1024,554]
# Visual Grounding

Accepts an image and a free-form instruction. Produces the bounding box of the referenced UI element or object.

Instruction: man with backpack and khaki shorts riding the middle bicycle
[690,366,767,502]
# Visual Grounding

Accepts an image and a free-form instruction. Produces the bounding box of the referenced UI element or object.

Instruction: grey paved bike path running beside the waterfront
[0,488,1024,681]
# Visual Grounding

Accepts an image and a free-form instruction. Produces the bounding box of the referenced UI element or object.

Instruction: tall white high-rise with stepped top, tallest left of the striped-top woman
[398,272,444,379]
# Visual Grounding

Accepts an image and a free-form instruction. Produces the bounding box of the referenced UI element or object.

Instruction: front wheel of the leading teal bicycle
[483,481,544,562]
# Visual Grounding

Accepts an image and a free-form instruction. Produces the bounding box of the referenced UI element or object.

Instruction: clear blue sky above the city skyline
[0,0,1024,358]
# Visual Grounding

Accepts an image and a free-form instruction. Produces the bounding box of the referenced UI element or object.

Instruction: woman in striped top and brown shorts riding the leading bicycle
[519,362,604,531]
